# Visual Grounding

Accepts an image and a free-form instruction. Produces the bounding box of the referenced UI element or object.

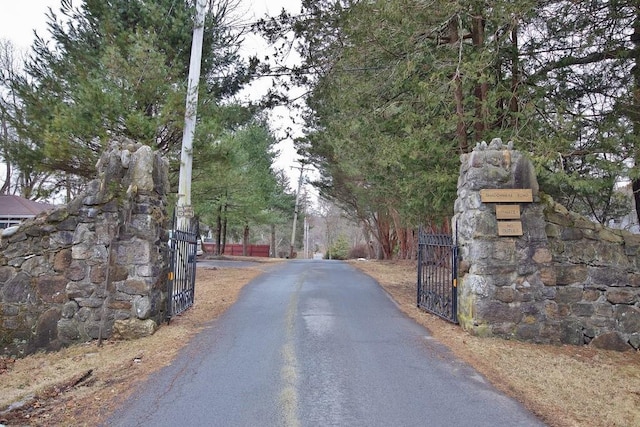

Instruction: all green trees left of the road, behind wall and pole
[0,0,294,254]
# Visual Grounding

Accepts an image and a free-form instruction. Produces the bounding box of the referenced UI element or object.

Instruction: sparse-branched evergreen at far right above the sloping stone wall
[520,1,640,224]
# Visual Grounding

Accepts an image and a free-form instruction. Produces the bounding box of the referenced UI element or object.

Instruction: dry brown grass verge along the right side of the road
[352,261,640,427]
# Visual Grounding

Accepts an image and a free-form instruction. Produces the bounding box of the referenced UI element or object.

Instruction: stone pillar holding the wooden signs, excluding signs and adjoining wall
[452,139,554,342]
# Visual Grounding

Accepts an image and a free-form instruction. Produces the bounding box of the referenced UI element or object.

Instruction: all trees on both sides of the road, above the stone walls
[0,0,640,258]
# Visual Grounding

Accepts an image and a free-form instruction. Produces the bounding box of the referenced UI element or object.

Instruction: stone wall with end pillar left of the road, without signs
[0,141,168,356]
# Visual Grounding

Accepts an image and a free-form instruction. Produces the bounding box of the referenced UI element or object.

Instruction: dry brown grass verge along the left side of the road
[0,260,272,426]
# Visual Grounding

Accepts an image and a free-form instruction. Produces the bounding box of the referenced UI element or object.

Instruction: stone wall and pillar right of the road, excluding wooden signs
[453,140,640,350]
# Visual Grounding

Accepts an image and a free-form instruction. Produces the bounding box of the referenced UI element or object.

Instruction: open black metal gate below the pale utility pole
[167,215,199,322]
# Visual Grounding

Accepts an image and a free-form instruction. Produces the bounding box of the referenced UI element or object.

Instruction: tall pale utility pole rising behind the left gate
[176,0,207,227]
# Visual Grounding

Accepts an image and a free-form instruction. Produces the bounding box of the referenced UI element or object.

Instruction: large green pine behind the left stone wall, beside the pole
[3,0,250,181]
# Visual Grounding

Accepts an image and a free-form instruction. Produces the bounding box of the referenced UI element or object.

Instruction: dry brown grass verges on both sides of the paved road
[0,262,640,427]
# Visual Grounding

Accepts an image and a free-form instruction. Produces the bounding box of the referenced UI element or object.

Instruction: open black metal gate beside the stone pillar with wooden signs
[418,230,458,323]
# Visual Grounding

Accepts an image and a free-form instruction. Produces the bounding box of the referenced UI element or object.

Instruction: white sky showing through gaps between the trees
[0,0,312,193]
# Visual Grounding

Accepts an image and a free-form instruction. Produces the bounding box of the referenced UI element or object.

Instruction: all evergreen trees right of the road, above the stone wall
[263,0,640,241]
